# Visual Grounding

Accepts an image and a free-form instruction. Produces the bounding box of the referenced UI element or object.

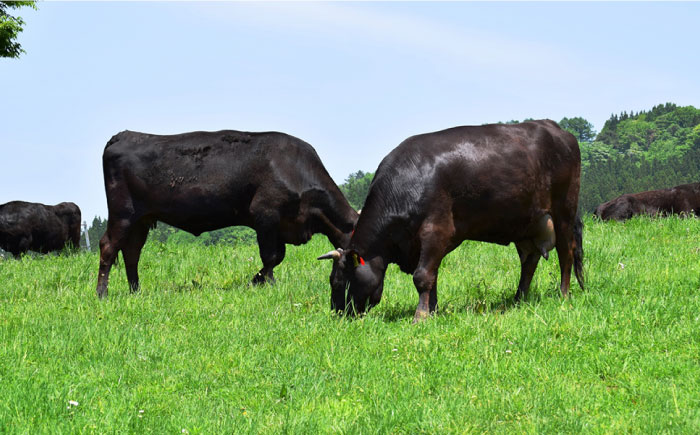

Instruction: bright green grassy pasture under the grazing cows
[0,218,700,434]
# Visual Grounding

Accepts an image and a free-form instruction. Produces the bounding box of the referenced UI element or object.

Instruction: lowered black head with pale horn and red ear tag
[318,249,384,315]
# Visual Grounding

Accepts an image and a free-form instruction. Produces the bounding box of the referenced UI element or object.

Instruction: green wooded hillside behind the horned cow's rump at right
[579,103,700,212]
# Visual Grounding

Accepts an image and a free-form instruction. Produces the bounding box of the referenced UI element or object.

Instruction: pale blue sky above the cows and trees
[0,2,700,221]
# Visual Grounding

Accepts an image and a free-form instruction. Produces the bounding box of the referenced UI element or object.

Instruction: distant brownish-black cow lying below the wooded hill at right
[594,183,700,221]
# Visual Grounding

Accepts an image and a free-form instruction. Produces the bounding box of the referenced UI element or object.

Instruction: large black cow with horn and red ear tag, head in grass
[319,120,583,322]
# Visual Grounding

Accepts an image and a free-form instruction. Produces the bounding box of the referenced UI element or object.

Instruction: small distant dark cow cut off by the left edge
[0,201,81,257]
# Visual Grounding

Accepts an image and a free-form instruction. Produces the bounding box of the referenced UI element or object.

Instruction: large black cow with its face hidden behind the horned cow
[97,130,357,297]
